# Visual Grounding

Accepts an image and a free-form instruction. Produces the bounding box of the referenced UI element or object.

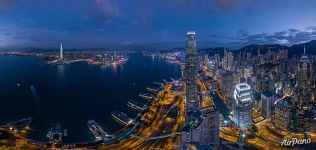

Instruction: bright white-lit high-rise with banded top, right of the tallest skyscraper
[233,82,252,130]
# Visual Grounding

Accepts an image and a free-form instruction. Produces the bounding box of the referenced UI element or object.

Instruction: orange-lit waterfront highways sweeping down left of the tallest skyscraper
[99,83,185,150]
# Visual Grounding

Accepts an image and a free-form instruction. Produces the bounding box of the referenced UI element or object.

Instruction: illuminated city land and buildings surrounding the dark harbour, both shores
[0,31,316,149]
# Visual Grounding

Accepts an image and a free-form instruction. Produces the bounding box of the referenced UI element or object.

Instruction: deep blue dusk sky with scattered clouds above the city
[0,0,316,49]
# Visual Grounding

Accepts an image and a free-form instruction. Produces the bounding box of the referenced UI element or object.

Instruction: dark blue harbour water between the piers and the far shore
[0,53,181,142]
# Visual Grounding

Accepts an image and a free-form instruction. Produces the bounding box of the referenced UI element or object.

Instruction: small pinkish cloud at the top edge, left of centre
[95,0,120,20]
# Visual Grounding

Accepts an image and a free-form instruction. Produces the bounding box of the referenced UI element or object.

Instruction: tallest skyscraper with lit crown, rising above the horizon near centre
[184,31,199,110]
